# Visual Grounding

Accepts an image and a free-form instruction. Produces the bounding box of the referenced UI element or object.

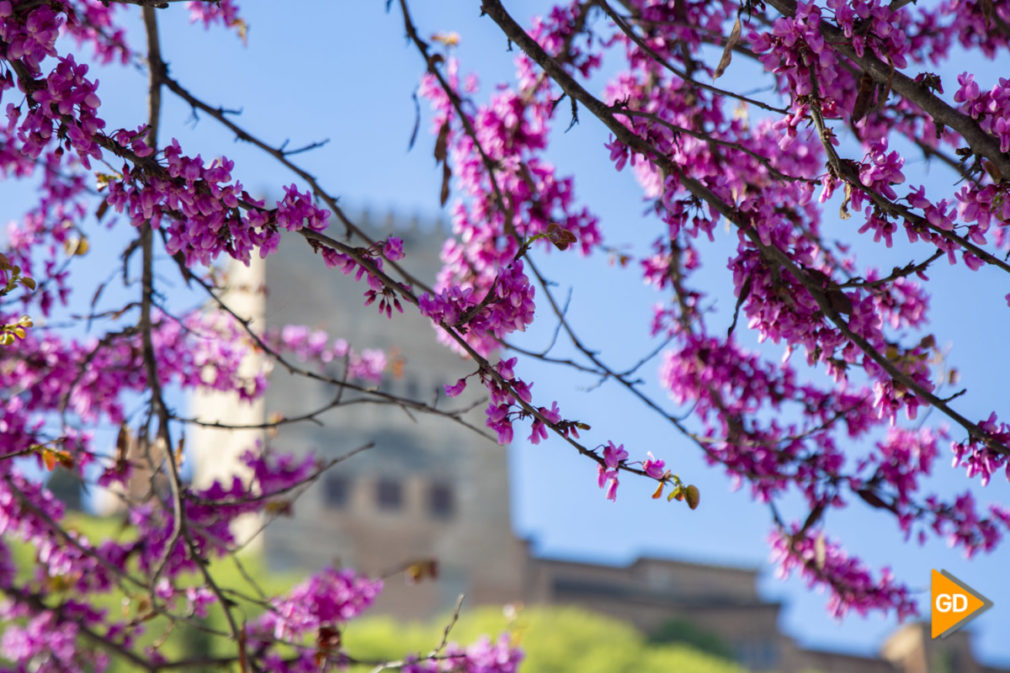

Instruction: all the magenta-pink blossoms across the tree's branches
[0,0,1010,673]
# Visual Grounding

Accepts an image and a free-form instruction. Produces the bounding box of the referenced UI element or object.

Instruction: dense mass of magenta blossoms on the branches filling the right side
[561,0,1010,615]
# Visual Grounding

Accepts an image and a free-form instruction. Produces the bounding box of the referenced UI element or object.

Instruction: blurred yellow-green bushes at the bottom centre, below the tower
[343,607,742,673]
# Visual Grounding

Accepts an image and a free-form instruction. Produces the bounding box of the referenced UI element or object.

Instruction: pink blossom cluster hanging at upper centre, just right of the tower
[419,2,601,443]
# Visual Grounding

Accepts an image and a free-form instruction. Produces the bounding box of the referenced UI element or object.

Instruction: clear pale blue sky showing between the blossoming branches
[0,0,1010,664]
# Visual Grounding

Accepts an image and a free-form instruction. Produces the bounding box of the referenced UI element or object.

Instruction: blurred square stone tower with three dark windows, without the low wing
[187,217,526,617]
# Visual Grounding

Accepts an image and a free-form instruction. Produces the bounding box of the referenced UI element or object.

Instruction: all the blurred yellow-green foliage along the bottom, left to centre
[12,514,743,673]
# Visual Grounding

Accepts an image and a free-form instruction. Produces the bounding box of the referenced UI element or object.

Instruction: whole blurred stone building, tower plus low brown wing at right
[192,211,998,673]
